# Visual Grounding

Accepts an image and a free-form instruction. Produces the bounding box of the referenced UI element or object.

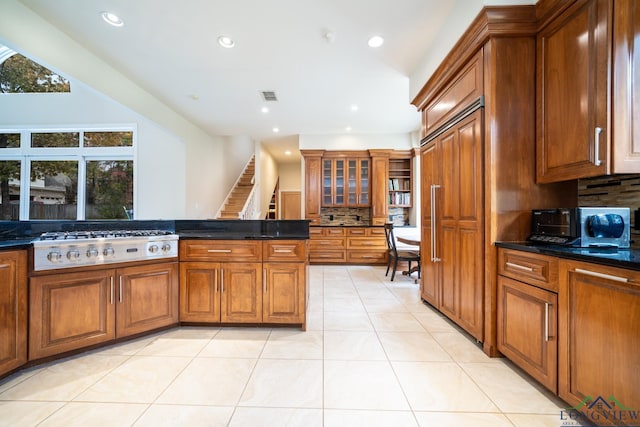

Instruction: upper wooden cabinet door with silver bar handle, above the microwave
[537,0,613,183]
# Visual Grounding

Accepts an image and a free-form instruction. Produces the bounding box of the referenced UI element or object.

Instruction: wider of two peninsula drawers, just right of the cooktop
[180,240,262,262]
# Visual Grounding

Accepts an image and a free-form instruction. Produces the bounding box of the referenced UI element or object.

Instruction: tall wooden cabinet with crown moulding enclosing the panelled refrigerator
[413,6,577,355]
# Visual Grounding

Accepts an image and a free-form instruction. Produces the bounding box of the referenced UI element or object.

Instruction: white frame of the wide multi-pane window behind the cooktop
[0,124,138,221]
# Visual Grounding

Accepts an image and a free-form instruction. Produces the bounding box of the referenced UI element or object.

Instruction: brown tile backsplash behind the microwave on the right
[578,174,640,249]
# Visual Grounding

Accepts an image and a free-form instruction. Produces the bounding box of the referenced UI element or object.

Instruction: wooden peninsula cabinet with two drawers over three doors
[180,240,307,329]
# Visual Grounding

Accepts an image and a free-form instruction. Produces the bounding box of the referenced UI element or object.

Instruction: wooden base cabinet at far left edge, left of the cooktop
[0,251,27,376]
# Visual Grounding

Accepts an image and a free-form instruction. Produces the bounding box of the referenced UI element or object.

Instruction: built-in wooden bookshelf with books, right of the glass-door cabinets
[388,152,413,226]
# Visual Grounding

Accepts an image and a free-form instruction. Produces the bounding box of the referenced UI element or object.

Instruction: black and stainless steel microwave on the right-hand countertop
[528,207,631,248]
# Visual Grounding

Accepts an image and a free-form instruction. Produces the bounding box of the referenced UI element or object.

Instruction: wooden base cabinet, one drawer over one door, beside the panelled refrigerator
[497,249,558,393]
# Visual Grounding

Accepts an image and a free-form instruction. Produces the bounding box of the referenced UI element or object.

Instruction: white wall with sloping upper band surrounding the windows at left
[0,0,252,218]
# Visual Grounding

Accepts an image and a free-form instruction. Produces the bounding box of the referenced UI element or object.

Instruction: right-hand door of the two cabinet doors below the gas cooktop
[116,262,178,338]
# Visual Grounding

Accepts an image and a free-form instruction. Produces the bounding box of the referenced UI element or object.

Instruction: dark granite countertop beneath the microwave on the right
[496,242,640,270]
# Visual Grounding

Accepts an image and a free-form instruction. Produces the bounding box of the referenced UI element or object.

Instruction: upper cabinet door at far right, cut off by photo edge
[611,0,640,173]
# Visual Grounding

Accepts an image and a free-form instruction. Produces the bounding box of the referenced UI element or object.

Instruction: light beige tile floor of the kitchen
[0,266,564,427]
